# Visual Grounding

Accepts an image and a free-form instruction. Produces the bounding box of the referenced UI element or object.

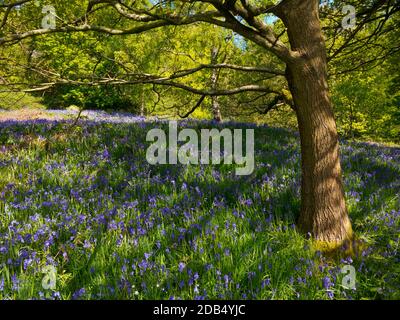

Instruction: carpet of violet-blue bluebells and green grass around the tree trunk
[0,114,400,299]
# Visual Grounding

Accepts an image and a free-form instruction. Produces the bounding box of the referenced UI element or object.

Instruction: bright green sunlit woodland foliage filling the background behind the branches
[0,0,400,142]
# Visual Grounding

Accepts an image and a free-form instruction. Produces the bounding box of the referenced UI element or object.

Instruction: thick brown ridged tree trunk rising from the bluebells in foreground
[280,0,352,250]
